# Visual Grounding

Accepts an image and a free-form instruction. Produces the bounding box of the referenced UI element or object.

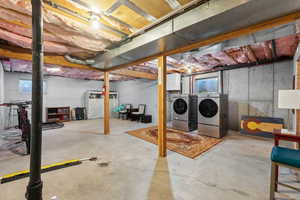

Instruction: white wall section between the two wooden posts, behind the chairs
[115,79,157,123]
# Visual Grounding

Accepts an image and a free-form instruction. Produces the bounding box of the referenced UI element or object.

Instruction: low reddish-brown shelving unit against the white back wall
[46,107,70,122]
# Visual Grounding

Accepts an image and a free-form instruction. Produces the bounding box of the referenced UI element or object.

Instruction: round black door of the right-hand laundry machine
[199,99,219,118]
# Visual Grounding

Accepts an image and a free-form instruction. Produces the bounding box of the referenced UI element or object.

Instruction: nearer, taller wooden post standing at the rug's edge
[158,56,167,157]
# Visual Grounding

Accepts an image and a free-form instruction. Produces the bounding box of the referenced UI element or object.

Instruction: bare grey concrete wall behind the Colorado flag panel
[223,61,293,130]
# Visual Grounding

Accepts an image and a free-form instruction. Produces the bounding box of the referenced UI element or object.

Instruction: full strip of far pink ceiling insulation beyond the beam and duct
[0,31,300,80]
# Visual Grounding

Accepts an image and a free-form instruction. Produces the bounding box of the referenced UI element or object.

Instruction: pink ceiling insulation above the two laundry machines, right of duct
[141,34,300,73]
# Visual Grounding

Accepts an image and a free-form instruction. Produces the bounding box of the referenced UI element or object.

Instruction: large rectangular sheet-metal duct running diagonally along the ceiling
[93,0,300,69]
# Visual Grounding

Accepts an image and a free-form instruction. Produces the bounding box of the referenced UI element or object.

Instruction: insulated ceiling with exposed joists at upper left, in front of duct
[0,0,202,58]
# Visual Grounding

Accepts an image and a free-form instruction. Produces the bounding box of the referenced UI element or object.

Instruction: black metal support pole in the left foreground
[25,0,44,200]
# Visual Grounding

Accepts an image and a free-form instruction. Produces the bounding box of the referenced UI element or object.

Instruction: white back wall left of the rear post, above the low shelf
[0,72,108,126]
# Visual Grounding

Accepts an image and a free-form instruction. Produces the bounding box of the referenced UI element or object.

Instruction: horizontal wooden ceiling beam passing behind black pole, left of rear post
[0,48,102,71]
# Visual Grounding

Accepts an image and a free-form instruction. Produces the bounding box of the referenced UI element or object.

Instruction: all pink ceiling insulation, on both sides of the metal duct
[0,0,299,80]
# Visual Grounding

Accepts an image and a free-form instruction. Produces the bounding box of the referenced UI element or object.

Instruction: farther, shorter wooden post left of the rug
[104,72,110,135]
